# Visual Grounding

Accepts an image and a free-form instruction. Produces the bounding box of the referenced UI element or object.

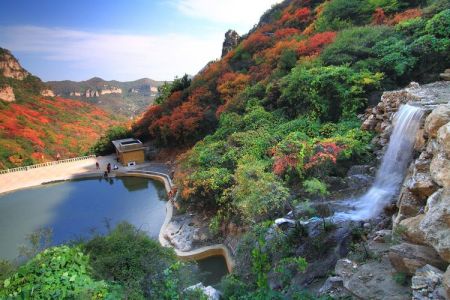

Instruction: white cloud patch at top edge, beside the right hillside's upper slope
[171,0,282,34]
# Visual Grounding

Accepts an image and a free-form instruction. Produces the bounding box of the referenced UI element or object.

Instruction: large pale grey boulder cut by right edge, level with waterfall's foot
[419,188,450,263]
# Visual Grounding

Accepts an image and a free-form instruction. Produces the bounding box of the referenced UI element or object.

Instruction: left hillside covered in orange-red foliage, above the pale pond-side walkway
[0,48,123,169]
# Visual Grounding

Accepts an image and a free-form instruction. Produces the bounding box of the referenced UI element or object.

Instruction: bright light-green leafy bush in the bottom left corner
[0,246,119,299]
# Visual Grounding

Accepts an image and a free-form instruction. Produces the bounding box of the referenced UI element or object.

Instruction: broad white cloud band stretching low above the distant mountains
[0,26,223,80]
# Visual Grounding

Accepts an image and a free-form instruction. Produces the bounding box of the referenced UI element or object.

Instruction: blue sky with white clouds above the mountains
[0,0,281,81]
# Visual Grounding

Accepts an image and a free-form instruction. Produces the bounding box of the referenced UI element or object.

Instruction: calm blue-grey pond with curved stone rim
[0,177,227,284]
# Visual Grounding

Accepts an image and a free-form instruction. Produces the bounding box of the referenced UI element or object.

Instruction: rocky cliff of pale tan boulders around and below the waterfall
[324,81,450,299]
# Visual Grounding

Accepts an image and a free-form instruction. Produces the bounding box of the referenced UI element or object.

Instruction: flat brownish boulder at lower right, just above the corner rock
[389,243,446,275]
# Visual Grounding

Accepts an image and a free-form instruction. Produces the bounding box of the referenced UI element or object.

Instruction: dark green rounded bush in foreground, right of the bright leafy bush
[84,223,192,299]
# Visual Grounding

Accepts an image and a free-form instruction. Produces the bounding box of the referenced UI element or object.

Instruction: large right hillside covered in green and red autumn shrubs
[133,0,450,299]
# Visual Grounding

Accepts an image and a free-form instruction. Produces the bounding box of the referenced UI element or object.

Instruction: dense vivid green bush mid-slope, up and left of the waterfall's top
[278,66,382,121]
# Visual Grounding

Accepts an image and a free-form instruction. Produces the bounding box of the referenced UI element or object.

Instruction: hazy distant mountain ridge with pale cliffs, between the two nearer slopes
[47,77,164,117]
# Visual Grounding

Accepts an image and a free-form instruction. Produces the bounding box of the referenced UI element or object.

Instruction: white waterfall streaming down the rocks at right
[333,104,423,221]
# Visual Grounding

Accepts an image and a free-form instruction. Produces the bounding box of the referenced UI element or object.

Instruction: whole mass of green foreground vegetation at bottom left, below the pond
[0,223,204,300]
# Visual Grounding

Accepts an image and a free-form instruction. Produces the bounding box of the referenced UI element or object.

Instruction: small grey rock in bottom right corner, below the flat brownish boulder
[411,265,445,300]
